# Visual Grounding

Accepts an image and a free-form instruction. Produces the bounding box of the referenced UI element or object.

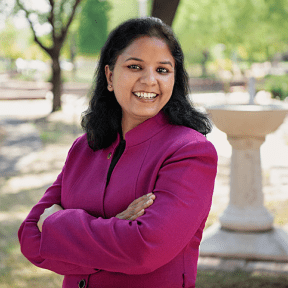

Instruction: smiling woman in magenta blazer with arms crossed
[19,18,217,288]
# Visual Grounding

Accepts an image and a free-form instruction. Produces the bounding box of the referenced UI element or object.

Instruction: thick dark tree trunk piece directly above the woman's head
[152,0,180,26]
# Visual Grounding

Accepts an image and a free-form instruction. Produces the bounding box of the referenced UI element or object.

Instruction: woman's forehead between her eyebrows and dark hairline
[119,36,175,64]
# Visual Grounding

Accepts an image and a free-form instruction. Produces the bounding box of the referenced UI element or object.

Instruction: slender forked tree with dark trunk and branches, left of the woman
[16,0,85,112]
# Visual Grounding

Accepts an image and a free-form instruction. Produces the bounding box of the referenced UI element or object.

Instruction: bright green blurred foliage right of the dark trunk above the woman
[173,0,288,63]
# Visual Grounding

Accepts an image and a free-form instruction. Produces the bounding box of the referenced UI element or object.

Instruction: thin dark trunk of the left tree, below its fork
[52,55,62,112]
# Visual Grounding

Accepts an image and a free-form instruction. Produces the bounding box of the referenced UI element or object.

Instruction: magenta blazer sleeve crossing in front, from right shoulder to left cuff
[40,141,217,274]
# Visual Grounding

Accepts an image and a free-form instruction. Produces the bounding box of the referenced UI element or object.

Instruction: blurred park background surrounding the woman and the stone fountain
[0,0,288,288]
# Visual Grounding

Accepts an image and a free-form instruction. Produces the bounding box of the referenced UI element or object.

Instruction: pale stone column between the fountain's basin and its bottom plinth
[219,137,273,231]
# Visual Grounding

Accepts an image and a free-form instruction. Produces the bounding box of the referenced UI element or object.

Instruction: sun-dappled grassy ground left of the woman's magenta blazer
[0,103,86,288]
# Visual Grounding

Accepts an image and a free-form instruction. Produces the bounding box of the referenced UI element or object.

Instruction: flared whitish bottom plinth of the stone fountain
[200,223,288,262]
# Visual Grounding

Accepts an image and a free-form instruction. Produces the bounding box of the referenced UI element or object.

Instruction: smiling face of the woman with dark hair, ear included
[105,36,175,133]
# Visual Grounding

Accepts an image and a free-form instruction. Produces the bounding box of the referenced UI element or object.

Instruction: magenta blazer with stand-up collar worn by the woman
[19,112,217,288]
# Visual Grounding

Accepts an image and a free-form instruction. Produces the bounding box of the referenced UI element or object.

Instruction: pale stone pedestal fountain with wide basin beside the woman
[200,86,288,261]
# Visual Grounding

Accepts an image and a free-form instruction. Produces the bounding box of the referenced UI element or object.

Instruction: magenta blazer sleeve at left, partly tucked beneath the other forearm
[18,140,95,275]
